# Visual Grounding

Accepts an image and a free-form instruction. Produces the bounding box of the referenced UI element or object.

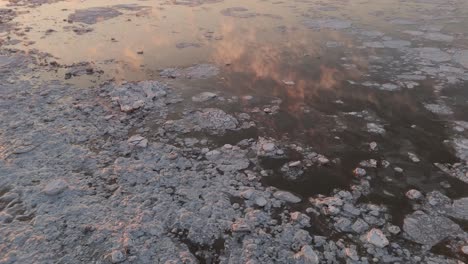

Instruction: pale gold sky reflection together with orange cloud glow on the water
[2,0,468,111]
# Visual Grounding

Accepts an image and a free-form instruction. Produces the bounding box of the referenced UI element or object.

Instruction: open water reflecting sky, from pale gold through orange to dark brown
[0,0,468,199]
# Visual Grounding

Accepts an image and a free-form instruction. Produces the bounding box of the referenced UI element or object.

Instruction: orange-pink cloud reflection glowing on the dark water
[211,21,367,112]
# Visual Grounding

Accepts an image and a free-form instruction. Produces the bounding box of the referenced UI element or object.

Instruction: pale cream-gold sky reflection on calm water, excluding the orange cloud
[6,0,464,71]
